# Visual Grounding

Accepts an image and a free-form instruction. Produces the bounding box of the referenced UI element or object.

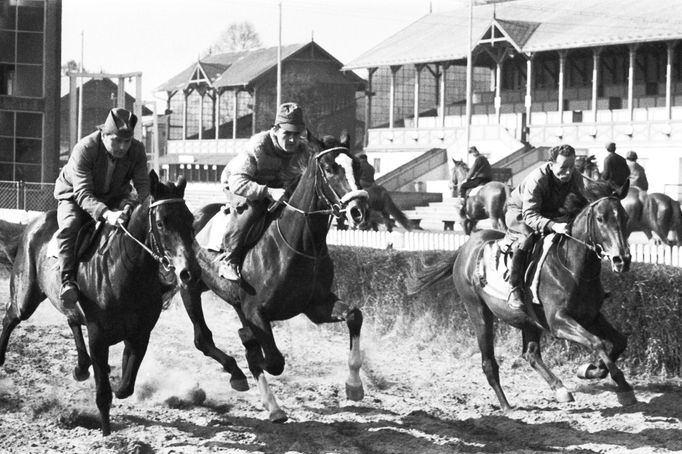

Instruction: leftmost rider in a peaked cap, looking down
[54,108,149,308]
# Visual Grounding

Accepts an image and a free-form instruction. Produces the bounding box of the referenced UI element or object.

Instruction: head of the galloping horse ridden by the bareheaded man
[571,196,631,273]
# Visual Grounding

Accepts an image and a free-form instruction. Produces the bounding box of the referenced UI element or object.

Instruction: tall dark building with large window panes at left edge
[0,0,61,183]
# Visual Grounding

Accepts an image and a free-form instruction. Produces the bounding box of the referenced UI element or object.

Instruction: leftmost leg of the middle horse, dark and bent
[180,285,249,391]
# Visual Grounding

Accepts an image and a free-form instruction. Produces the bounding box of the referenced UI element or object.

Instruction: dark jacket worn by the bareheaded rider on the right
[508,163,587,233]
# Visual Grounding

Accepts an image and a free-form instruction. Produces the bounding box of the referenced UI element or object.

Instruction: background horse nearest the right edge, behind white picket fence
[622,187,682,246]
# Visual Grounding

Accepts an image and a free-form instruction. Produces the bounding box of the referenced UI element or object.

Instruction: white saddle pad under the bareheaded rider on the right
[476,234,555,304]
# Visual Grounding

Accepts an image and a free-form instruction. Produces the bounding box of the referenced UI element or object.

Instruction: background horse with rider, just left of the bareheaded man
[452,159,509,235]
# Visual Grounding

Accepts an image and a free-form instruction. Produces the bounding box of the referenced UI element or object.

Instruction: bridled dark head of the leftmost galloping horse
[129,170,201,286]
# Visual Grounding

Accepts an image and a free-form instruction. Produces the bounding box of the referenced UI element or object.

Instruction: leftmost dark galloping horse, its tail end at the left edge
[0,171,201,435]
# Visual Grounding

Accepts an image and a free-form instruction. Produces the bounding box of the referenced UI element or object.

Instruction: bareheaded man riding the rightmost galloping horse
[505,145,587,310]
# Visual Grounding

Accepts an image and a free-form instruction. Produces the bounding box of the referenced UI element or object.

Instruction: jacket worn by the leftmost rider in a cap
[54,131,149,219]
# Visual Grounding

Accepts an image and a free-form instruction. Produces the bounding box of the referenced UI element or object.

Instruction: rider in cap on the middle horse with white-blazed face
[219,102,308,281]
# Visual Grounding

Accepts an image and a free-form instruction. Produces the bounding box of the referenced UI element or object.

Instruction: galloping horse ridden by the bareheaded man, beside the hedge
[412,190,636,411]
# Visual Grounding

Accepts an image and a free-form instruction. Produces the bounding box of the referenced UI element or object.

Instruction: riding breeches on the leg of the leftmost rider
[57,200,91,276]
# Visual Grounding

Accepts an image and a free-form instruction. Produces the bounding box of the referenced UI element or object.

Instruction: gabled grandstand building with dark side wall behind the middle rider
[157,41,364,181]
